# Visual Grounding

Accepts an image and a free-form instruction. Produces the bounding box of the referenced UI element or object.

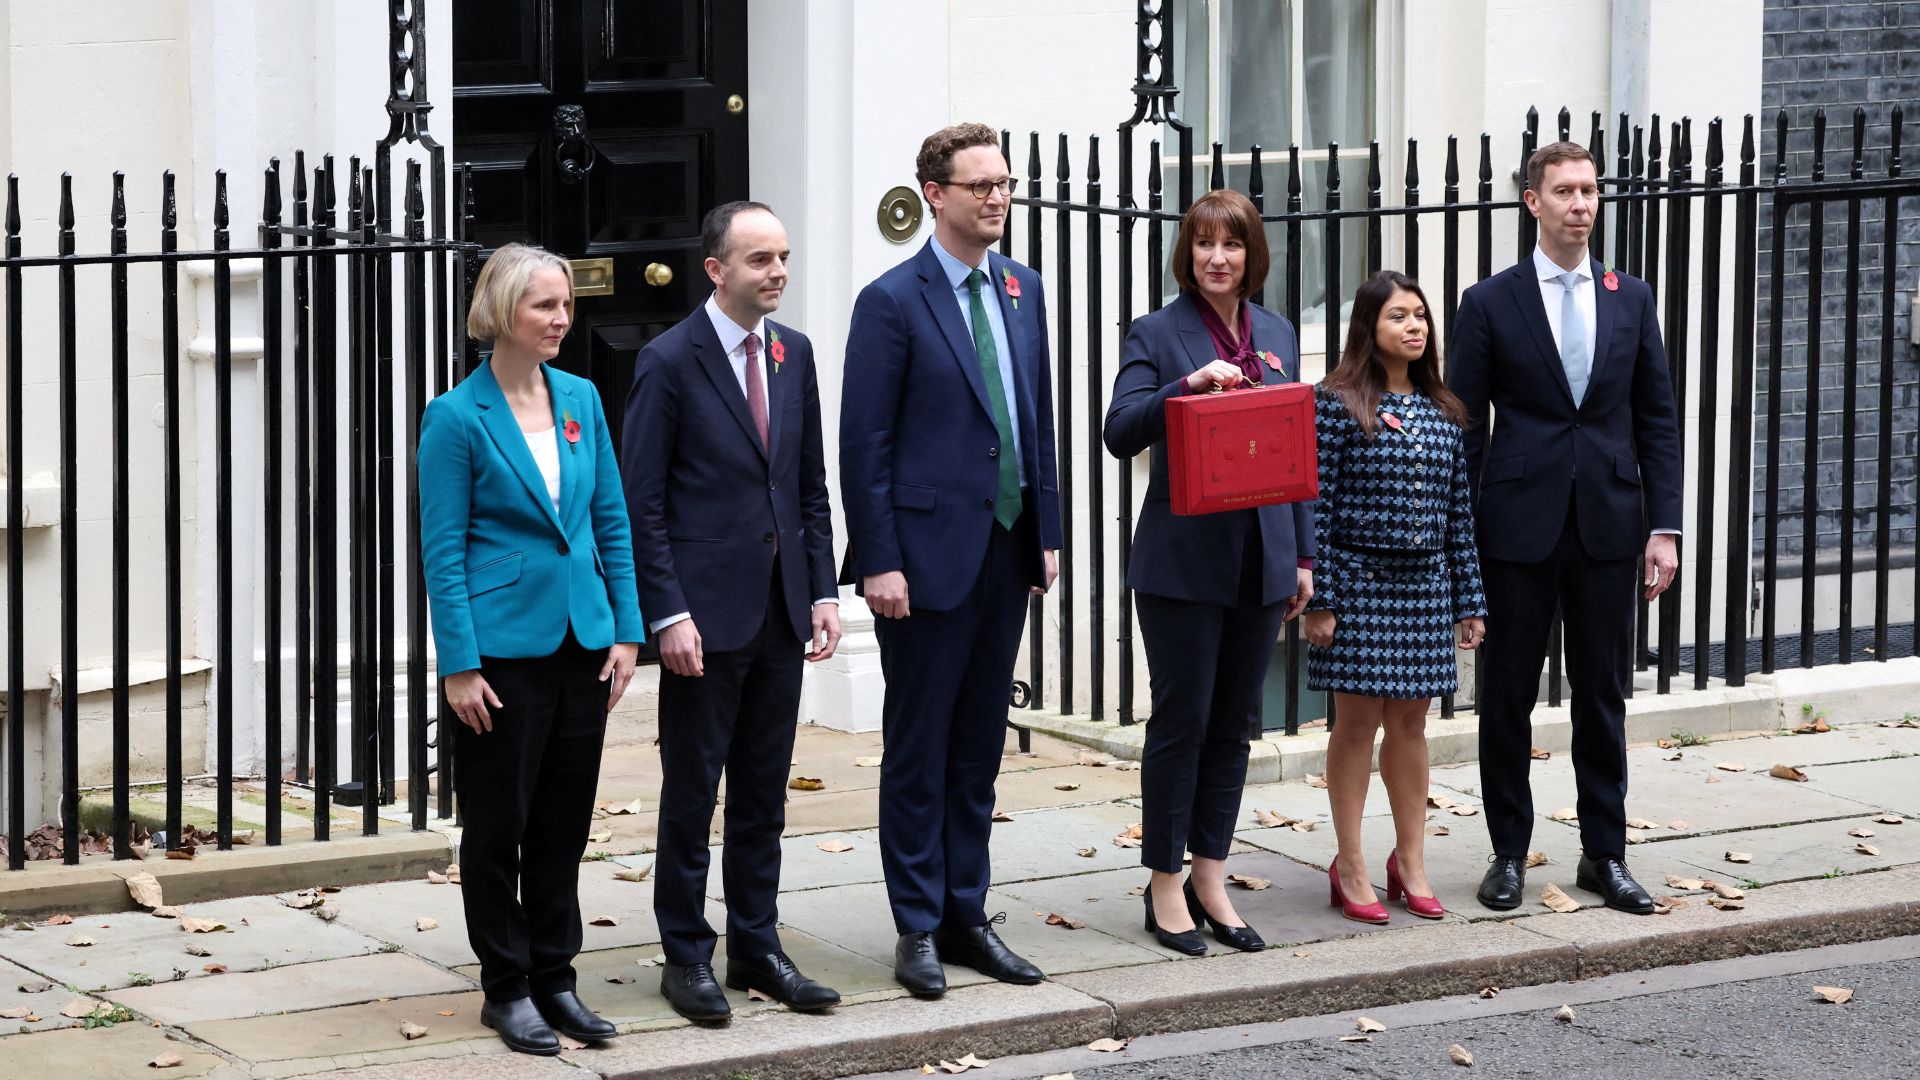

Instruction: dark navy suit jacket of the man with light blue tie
[1448,258,1682,563]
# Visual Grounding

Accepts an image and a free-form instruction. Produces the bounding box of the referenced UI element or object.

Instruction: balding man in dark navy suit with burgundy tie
[620,202,841,1022]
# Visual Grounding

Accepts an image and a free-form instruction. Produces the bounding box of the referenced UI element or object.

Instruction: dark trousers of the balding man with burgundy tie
[653,565,804,965]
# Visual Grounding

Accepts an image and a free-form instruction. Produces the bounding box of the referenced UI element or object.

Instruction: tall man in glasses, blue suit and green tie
[841,123,1062,997]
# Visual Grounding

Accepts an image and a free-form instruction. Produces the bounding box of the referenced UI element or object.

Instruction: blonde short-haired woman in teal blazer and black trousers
[419,244,641,1055]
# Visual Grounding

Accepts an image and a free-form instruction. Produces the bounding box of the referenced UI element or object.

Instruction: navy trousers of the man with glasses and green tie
[874,496,1039,934]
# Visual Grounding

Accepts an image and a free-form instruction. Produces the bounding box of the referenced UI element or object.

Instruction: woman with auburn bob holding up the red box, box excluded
[1104,190,1313,955]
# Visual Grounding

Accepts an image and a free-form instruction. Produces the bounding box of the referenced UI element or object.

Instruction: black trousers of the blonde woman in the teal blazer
[449,630,607,1001]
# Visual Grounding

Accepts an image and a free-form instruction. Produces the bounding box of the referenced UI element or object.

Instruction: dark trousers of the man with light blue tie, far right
[1478,505,1636,859]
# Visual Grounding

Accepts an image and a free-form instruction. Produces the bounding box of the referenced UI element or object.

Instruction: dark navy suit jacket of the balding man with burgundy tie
[620,307,835,651]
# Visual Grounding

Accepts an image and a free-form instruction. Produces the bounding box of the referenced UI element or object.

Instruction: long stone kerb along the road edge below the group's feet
[572,867,1920,1080]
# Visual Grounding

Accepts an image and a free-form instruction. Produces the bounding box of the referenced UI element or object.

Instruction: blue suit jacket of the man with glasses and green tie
[841,240,1060,611]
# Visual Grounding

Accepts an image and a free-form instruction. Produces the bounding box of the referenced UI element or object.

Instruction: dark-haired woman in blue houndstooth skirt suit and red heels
[1304,271,1486,922]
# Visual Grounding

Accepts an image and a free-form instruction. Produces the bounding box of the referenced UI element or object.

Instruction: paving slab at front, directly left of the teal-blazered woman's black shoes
[186,990,487,1063]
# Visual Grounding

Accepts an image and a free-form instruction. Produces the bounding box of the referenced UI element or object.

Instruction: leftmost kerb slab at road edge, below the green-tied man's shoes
[564,982,1112,1080]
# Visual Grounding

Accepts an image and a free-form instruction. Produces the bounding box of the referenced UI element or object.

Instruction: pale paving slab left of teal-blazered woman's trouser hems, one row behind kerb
[109,953,474,1024]
